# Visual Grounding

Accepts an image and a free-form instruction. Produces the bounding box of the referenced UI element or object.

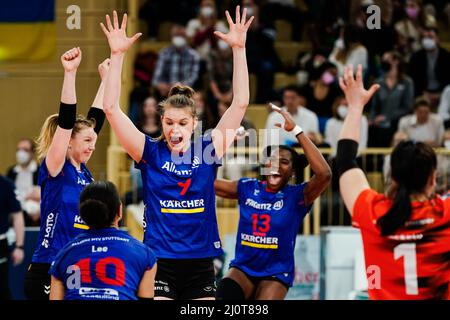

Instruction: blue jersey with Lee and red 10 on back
[49,228,156,300]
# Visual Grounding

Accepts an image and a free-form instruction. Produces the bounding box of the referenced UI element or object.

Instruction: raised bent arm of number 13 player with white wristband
[272,105,331,205]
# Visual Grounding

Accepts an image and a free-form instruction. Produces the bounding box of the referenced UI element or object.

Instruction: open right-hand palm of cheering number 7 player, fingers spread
[214,6,254,48]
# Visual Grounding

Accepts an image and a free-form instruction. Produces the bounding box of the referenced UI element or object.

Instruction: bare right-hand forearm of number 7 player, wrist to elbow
[231,48,250,108]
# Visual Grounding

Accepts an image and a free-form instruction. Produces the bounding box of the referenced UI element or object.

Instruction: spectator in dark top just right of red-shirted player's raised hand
[369,51,414,147]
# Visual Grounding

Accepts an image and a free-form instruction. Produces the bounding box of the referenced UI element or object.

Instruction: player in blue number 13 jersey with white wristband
[215,108,331,300]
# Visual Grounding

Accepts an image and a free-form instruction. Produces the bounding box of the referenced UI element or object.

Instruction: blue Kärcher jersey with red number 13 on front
[230,179,311,286]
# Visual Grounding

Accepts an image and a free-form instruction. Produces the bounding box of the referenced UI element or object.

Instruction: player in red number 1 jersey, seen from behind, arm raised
[336,66,450,300]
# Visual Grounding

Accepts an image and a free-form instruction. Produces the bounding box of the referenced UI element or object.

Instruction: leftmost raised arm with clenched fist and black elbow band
[45,48,81,177]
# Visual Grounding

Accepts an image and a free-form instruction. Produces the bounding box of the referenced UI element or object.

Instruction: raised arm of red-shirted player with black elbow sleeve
[336,65,380,215]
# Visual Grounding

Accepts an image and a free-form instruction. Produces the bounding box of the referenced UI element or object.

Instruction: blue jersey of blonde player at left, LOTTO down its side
[32,160,93,263]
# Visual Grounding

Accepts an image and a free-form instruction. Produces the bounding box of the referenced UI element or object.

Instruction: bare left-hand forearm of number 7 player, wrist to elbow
[103,53,124,114]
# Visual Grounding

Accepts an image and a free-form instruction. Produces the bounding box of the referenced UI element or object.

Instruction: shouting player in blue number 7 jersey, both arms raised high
[101,7,253,299]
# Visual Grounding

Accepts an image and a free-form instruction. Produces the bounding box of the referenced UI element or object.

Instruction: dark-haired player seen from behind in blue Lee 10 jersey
[50,181,156,300]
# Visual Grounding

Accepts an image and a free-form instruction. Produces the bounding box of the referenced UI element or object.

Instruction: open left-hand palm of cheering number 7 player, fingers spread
[100,10,142,54]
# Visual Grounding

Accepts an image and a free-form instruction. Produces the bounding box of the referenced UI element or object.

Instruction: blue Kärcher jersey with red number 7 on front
[137,136,223,259]
